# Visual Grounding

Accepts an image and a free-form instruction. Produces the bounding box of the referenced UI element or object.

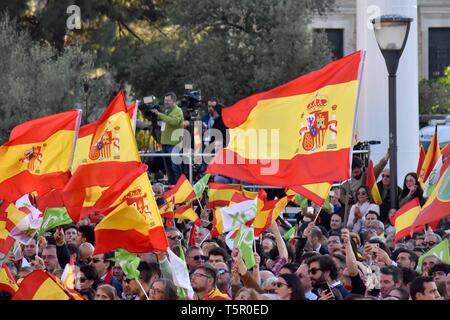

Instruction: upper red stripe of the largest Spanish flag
[223,51,362,128]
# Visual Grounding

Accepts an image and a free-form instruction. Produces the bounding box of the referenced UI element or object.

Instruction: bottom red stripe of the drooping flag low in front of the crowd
[94,227,168,255]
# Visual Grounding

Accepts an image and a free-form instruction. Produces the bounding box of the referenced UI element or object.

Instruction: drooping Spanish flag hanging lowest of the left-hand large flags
[95,165,168,253]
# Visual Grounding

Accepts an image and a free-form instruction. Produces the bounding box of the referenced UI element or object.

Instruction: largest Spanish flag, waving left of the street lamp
[208,51,364,186]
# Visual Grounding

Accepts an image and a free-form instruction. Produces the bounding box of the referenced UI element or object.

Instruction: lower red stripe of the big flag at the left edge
[0,170,70,202]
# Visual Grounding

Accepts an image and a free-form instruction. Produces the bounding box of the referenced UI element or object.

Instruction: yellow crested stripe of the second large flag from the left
[72,112,140,172]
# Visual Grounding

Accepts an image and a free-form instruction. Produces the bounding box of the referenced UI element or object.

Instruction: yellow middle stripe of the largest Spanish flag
[227,80,358,159]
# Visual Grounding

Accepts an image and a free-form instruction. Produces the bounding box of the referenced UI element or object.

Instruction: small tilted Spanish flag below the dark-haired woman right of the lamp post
[390,198,420,242]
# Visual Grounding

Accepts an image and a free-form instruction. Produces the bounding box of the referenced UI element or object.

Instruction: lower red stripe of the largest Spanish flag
[207,148,350,187]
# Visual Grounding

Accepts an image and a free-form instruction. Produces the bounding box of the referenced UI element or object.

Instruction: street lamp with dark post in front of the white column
[372,15,412,209]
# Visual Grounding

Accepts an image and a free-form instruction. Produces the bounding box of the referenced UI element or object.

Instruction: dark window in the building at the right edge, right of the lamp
[428,28,450,79]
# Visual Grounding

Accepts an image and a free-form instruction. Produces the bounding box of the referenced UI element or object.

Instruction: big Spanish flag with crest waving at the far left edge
[0,110,81,202]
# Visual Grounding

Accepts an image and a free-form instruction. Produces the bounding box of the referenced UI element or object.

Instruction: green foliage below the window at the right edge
[419,67,450,114]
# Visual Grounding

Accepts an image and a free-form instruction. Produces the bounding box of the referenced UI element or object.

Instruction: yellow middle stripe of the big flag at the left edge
[0,130,75,182]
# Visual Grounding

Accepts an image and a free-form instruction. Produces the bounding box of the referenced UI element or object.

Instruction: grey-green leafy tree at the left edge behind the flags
[0,15,118,143]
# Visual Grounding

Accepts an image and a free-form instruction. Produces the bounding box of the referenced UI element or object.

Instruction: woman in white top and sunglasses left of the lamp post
[347,186,380,233]
